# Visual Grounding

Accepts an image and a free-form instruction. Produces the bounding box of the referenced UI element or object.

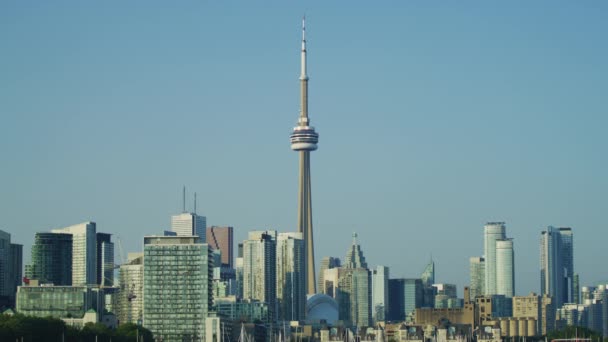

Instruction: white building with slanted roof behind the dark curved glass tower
[51,222,97,286]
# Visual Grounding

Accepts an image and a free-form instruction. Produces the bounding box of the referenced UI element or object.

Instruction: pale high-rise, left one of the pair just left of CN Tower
[243,231,277,319]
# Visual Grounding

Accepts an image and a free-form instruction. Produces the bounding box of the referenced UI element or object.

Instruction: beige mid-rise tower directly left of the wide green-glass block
[115,253,144,324]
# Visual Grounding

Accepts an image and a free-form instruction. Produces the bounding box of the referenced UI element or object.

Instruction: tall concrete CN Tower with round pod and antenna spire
[290,19,319,294]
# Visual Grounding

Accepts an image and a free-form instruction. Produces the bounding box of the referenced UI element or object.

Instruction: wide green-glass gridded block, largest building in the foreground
[143,236,212,341]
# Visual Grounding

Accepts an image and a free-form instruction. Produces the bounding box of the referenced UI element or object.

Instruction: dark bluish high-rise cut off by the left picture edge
[0,230,23,307]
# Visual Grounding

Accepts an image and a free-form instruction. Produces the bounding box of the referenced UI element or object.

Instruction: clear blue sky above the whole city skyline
[0,1,608,296]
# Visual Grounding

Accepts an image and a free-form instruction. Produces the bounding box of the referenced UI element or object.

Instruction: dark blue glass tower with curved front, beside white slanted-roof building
[25,233,72,286]
